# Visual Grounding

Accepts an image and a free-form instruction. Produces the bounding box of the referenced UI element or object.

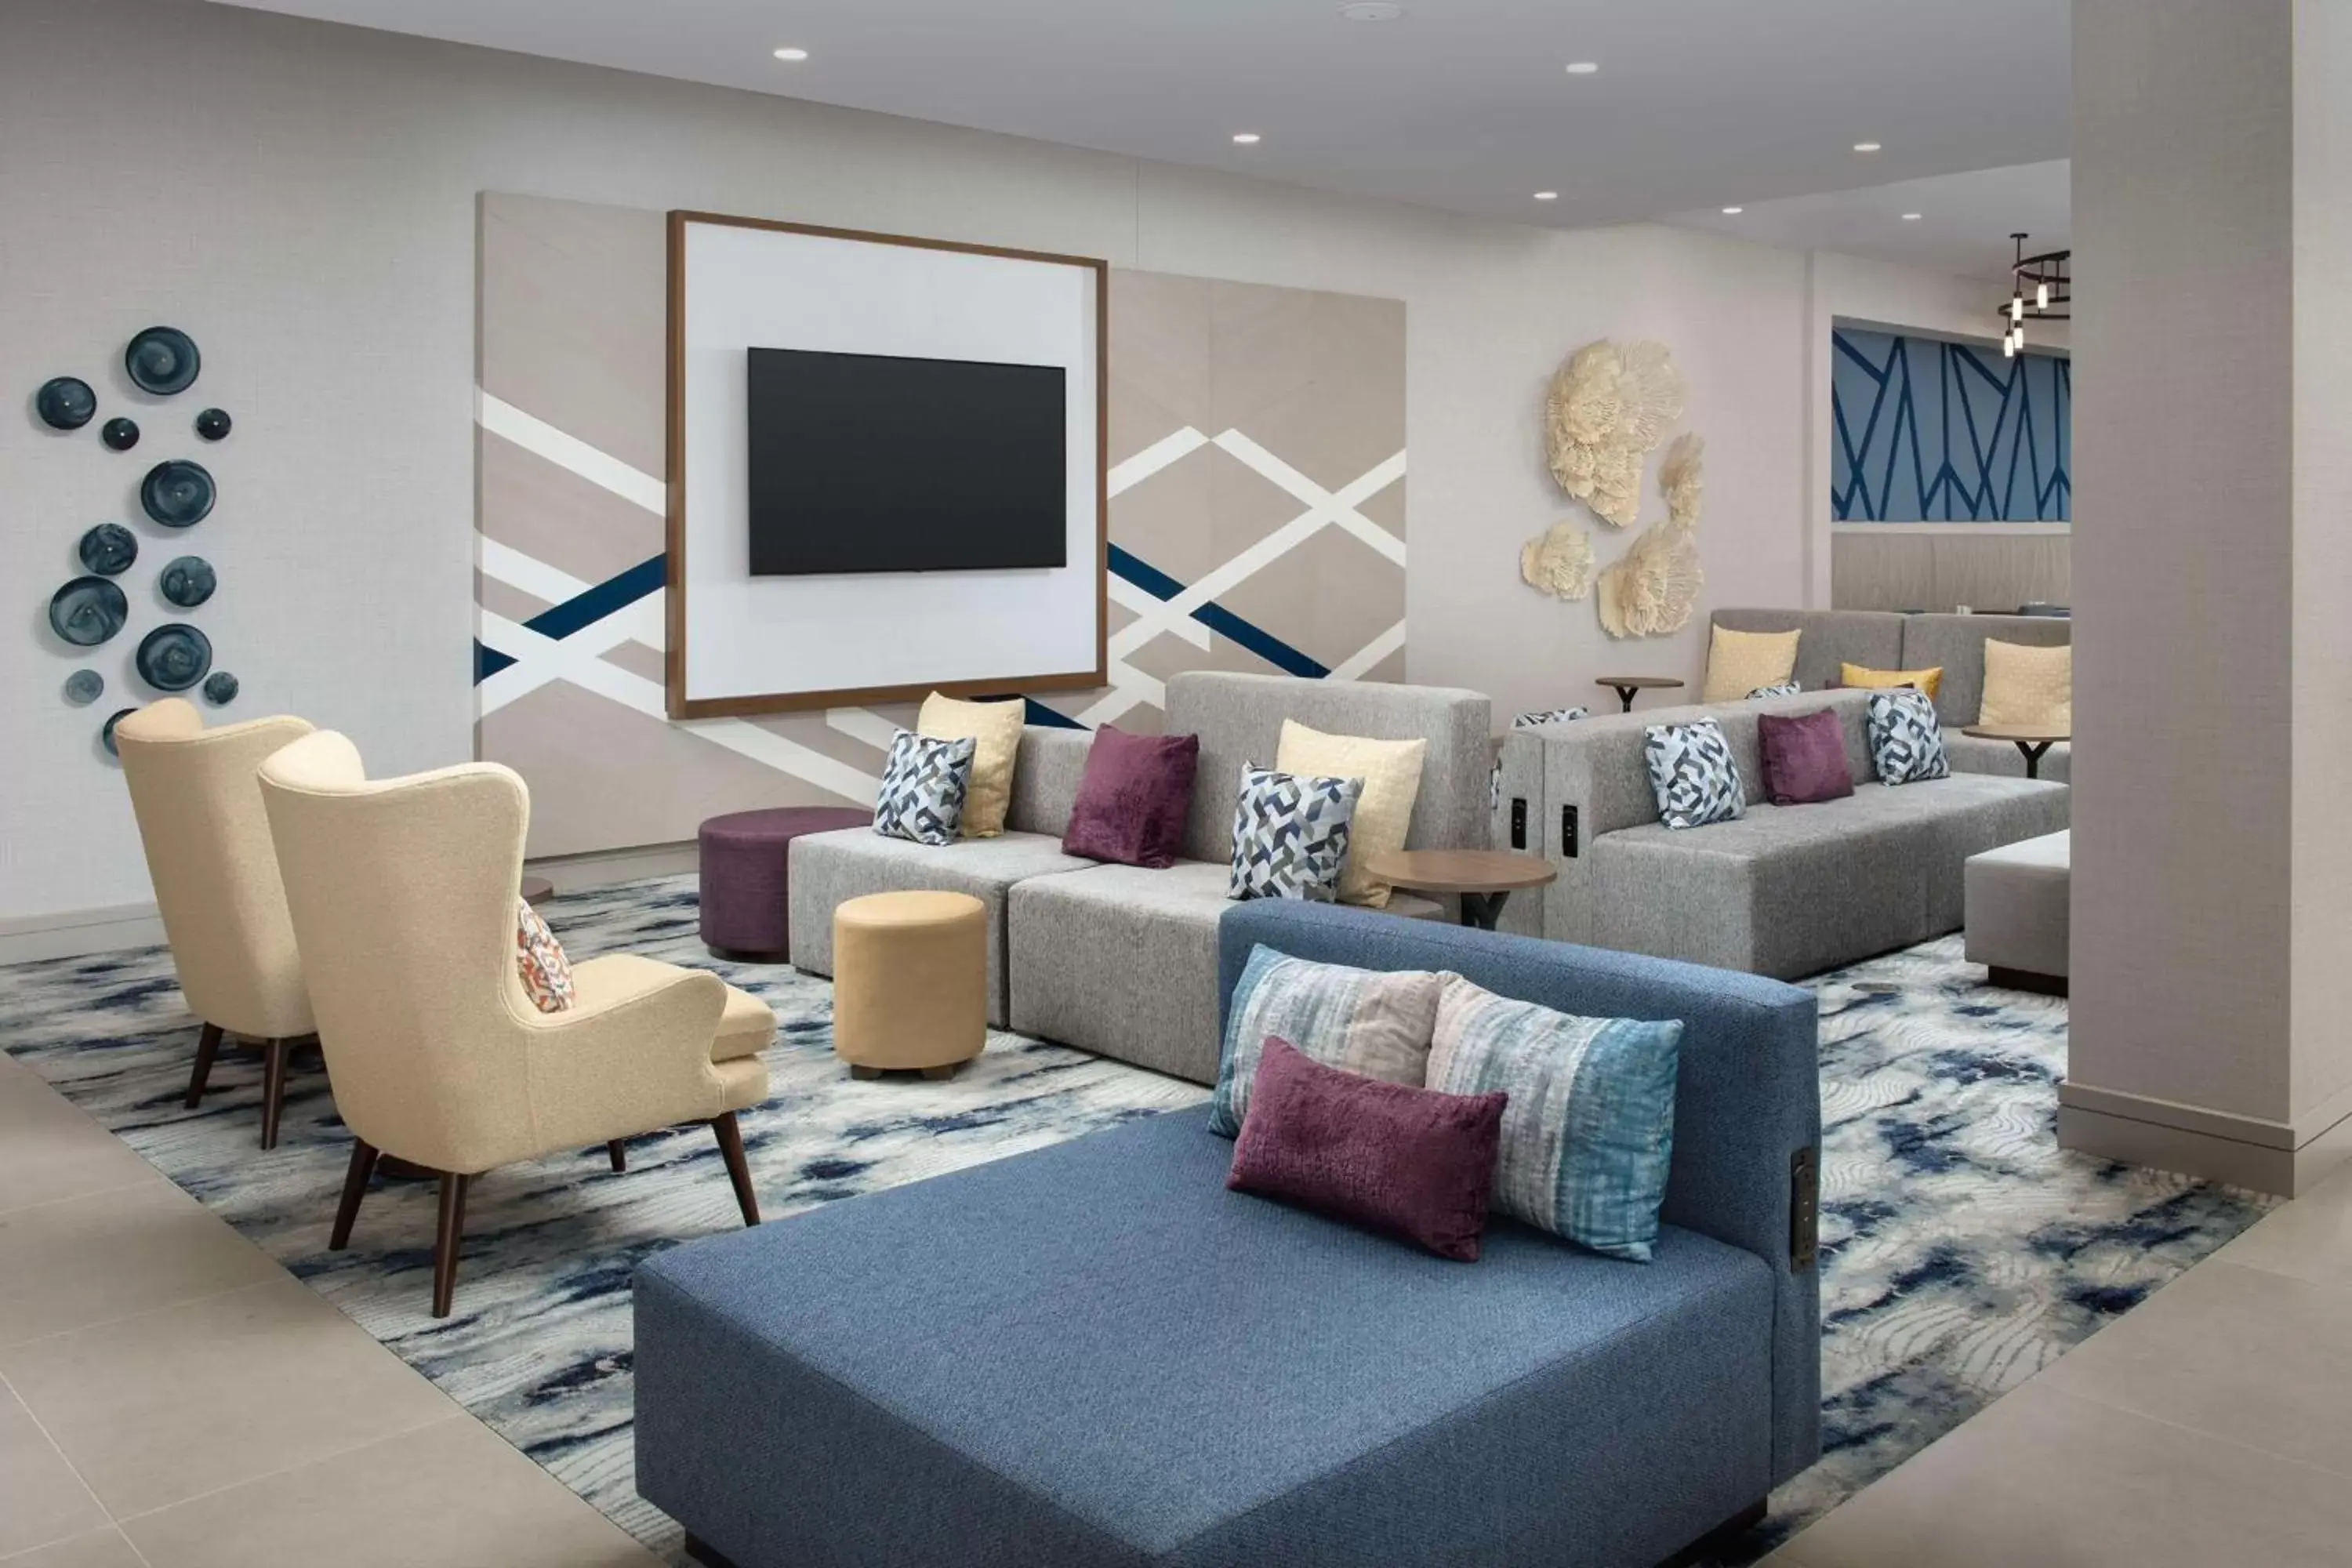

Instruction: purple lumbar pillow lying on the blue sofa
[1225,1034,1508,1262]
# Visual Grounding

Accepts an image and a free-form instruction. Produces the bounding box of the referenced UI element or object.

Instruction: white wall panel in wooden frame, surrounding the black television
[668,212,1105,717]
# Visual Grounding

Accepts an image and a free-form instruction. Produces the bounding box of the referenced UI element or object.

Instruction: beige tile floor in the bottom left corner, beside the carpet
[0,1053,654,1568]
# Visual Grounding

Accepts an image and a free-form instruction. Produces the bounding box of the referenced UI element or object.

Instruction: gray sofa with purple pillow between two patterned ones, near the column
[1501,691,2070,980]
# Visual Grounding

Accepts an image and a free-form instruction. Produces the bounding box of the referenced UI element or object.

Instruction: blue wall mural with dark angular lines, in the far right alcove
[1830,327,2074,522]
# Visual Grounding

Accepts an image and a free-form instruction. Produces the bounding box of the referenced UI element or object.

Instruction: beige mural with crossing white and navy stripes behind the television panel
[473,193,1404,855]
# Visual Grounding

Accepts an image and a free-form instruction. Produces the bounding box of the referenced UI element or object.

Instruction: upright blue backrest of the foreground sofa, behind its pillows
[1218,900,1820,1483]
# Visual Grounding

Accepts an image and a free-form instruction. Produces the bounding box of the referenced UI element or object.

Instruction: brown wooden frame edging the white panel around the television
[663,209,1110,720]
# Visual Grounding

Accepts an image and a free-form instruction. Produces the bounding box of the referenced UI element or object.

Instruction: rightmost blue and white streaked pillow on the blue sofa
[1428,973,1682,1262]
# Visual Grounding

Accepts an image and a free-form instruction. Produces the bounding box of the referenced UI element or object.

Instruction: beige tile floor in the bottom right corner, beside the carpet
[1766,1166,2352,1568]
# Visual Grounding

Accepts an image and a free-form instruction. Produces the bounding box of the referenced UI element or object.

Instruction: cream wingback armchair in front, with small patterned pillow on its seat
[261,731,776,1316]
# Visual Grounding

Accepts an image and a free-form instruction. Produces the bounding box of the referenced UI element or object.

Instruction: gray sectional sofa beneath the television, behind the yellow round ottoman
[790,670,1489,1083]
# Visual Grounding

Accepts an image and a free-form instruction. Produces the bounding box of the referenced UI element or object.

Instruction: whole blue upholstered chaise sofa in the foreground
[635,902,1820,1568]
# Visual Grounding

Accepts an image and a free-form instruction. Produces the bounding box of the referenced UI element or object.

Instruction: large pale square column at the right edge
[2058,0,2352,1192]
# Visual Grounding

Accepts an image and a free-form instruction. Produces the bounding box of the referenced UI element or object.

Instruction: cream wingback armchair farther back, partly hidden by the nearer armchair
[115,696,313,1149]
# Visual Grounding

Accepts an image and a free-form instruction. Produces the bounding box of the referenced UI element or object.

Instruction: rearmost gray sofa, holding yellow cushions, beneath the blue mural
[1710,609,2074,783]
